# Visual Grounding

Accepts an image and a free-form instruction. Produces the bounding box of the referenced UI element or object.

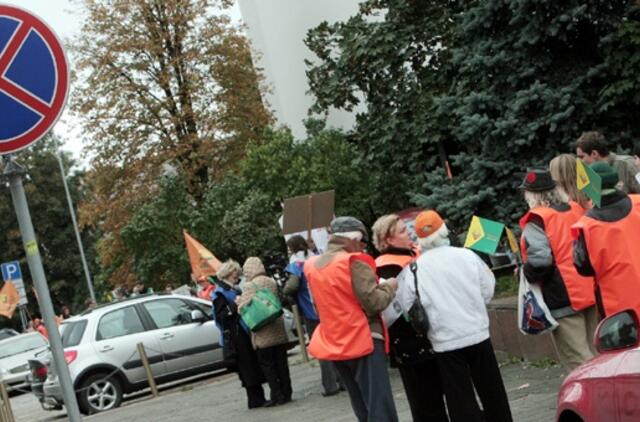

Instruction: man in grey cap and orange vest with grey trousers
[304,217,398,422]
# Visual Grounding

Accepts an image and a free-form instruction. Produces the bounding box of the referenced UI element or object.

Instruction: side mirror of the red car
[594,309,640,353]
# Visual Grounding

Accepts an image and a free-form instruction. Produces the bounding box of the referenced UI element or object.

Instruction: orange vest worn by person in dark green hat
[571,195,640,317]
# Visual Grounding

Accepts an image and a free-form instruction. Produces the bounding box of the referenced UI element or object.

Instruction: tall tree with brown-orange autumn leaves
[71,0,271,283]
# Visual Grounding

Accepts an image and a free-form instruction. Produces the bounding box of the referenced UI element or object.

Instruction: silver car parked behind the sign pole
[43,294,295,414]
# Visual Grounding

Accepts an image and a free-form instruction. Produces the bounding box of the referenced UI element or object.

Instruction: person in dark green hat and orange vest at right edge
[571,162,640,318]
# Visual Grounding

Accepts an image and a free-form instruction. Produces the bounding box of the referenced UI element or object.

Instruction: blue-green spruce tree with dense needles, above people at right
[416,0,627,234]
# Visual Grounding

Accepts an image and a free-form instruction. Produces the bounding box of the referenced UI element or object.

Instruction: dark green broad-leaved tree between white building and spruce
[305,0,460,214]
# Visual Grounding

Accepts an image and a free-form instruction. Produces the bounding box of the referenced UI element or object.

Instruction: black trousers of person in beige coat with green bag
[256,344,293,403]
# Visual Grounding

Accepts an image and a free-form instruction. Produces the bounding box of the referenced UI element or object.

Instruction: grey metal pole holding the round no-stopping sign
[3,155,82,422]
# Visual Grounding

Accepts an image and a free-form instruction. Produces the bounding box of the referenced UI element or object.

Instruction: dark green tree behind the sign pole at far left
[0,137,95,324]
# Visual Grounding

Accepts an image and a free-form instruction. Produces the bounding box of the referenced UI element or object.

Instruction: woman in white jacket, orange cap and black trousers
[396,210,512,422]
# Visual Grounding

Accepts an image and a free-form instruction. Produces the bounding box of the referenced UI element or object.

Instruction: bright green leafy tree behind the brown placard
[193,130,373,260]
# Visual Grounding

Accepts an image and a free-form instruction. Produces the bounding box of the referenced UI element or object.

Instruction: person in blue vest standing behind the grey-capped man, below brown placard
[282,235,344,397]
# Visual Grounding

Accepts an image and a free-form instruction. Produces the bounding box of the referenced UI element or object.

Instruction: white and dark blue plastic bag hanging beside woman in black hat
[518,267,558,334]
